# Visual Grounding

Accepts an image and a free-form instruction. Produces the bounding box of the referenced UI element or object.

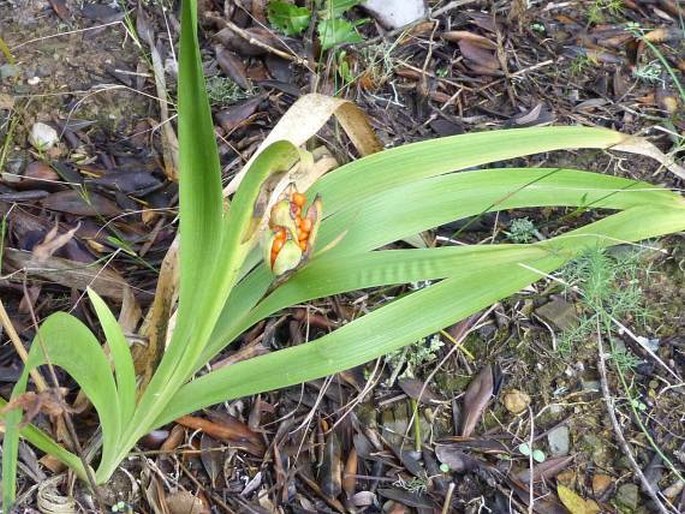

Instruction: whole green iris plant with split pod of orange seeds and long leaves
[2,1,685,504]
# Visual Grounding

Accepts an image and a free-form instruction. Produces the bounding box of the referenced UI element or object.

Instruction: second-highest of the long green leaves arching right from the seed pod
[320,168,680,254]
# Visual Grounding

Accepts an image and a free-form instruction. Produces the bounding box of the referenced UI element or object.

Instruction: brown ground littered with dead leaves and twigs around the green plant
[0,0,685,513]
